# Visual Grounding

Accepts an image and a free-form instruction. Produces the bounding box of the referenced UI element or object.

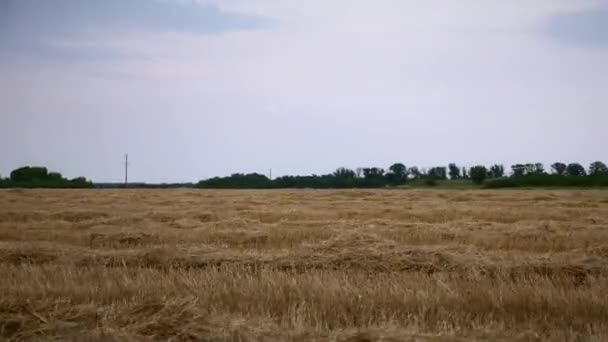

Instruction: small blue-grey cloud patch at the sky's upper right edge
[546,7,608,47]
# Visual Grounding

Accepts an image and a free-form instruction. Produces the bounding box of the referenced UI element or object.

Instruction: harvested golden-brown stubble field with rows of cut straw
[0,190,608,342]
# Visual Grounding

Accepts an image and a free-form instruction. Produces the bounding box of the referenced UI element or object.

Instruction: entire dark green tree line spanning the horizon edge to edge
[0,161,608,189]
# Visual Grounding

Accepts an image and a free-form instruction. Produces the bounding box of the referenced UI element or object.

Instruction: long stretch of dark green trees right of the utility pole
[197,161,608,189]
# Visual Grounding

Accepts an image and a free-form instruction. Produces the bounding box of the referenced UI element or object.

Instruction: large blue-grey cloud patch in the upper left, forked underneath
[0,0,275,62]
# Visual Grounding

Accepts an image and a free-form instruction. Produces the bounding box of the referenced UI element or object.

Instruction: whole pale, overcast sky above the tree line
[0,0,608,182]
